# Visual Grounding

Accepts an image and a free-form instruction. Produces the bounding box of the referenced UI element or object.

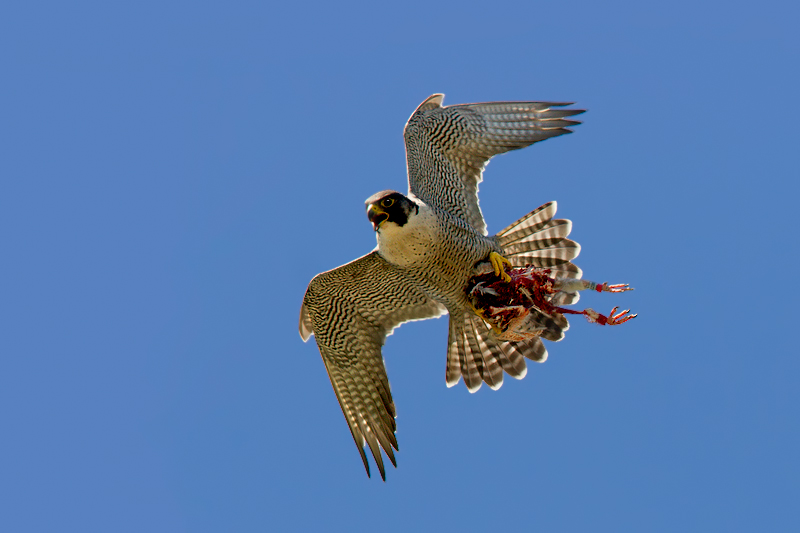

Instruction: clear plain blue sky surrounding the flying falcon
[0,1,800,532]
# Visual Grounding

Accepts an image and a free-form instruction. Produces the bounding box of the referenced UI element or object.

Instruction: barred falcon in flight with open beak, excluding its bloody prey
[300,94,583,480]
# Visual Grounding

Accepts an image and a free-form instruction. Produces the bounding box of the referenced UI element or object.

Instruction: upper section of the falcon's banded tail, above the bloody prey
[495,202,583,306]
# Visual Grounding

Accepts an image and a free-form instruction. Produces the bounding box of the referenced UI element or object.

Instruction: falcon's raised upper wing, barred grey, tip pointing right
[404,94,583,235]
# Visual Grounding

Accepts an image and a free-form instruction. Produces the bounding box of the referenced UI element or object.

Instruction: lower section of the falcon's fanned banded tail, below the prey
[445,313,547,392]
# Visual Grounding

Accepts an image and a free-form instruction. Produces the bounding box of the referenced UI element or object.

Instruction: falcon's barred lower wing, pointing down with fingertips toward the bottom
[300,251,445,480]
